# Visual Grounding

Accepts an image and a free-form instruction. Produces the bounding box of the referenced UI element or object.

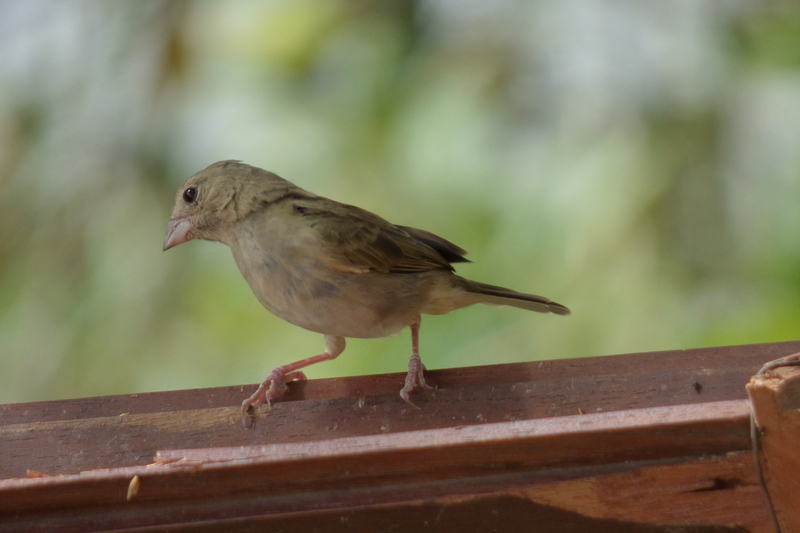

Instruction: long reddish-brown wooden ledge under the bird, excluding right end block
[0,342,800,532]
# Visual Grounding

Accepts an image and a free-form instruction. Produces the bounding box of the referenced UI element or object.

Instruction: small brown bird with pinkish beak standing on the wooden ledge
[164,161,570,415]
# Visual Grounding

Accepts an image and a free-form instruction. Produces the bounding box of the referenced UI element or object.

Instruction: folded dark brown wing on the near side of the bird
[293,197,466,273]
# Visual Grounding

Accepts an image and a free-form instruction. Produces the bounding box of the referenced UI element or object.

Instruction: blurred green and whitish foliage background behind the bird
[0,0,800,403]
